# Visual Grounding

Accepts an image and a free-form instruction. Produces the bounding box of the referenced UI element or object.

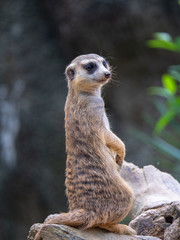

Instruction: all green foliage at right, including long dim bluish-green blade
[133,30,180,180]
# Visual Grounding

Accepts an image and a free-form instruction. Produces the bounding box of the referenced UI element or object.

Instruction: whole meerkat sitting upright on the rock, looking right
[35,54,136,240]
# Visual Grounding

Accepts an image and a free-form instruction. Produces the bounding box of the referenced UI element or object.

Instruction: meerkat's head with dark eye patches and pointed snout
[65,54,111,92]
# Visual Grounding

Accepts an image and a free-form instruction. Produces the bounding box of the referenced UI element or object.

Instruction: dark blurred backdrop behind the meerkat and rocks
[0,0,180,240]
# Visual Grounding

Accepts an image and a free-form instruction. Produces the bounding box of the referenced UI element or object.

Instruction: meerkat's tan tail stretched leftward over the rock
[34,209,95,240]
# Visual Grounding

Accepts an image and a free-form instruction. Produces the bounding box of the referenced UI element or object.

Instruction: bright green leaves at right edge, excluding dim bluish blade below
[148,33,180,134]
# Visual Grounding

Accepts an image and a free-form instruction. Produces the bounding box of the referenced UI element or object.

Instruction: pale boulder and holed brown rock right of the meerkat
[121,162,180,240]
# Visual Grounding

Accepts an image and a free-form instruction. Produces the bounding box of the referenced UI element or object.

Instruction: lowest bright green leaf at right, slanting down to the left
[154,111,175,134]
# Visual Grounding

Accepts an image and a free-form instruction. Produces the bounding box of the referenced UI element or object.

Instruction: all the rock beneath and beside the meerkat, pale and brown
[28,162,180,240]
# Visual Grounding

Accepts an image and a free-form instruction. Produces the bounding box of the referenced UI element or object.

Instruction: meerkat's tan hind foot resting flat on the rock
[99,224,137,235]
